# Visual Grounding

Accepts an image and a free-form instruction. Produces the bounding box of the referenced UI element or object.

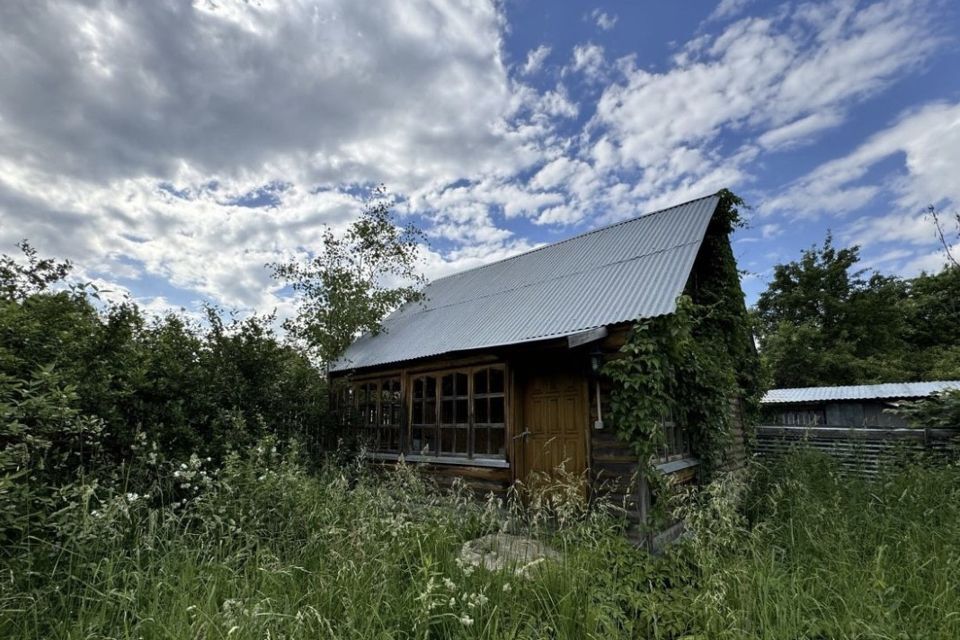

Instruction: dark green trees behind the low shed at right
[756,234,960,387]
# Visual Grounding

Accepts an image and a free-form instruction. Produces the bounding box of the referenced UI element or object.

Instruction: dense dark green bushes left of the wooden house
[0,240,327,540]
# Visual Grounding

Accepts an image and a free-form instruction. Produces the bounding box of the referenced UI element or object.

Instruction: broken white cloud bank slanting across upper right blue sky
[588,0,938,220]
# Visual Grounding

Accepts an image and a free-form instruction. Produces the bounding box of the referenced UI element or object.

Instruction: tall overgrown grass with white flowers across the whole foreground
[0,445,960,639]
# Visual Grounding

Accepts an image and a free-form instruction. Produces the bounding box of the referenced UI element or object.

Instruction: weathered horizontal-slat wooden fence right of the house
[753,425,960,475]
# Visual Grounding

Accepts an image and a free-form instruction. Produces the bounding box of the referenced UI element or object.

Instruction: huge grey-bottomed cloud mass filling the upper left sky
[0,0,556,306]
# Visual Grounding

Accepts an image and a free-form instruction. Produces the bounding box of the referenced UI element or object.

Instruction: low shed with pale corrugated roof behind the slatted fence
[761,380,960,428]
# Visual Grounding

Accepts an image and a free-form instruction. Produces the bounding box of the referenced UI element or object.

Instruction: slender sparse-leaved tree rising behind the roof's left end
[270,185,425,365]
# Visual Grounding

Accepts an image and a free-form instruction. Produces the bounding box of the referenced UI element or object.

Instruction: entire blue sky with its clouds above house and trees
[0,0,960,316]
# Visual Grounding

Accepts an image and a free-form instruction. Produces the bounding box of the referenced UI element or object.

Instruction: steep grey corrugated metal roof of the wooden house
[332,196,719,371]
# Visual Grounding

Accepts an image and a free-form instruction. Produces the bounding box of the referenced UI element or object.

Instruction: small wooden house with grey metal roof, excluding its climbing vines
[331,195,743,519]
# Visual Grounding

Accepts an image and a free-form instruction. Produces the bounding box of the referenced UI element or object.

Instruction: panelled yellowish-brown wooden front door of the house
[519,372,589,481]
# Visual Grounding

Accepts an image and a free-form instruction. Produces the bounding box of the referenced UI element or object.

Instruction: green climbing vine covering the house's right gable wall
[604,190,761,504]
